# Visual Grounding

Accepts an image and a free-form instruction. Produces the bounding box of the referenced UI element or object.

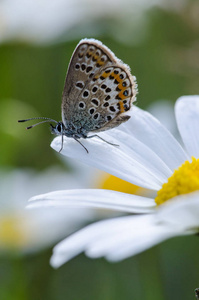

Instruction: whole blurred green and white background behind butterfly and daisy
[0,0,199,300]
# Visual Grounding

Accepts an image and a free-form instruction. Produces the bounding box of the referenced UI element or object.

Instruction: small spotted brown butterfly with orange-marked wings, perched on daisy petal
[18,39,137,153]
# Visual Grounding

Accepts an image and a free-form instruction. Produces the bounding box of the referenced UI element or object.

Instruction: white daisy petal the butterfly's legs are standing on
[51,129,168,190]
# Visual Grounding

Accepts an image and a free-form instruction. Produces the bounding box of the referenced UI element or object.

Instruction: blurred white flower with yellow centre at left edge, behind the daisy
[0,167,98,253]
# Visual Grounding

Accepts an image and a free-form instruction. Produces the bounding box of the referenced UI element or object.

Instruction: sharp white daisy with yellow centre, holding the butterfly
[30,96,199,267]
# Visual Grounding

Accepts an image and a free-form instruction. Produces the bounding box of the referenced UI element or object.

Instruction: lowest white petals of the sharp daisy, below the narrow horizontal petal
[51,215,182,268]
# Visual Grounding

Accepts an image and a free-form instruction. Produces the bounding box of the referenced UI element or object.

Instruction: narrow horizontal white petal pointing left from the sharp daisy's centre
[28,189,156,213]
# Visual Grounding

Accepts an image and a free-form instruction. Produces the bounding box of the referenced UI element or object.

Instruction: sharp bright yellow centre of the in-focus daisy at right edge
[155,157,199,205]
